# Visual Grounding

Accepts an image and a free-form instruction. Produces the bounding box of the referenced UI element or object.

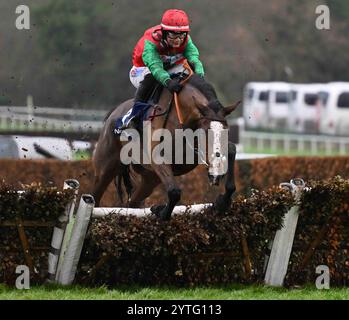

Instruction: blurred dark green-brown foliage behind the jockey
[0,0,349,109]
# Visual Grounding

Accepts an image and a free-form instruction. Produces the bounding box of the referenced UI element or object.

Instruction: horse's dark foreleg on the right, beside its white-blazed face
[214,142,236,213]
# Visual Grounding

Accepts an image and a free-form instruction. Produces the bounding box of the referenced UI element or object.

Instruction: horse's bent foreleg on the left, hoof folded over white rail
[153,164,181,220]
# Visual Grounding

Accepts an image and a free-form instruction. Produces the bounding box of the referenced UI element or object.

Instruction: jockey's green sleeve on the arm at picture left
[142,40,171,85]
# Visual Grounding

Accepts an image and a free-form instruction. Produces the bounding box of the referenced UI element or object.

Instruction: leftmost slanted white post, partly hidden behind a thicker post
[48,179,80,282]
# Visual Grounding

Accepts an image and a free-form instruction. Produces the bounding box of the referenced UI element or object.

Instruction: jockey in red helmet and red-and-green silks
[121,9,204,130]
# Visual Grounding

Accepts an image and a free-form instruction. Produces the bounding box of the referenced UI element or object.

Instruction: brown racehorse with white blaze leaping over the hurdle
[92,65,240,220]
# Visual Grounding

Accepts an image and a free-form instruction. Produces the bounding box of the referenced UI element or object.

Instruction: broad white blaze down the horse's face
[208,121,228,185]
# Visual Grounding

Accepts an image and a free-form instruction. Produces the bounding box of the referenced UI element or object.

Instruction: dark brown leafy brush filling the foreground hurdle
[0,172,349,286]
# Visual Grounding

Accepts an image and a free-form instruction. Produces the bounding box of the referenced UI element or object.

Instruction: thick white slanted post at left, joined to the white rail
[57,194,95,285]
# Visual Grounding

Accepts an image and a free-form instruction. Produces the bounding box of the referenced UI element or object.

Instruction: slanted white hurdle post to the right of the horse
[264,179,305,287]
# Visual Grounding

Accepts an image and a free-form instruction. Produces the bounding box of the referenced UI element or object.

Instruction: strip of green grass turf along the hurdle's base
[0,285,349,300]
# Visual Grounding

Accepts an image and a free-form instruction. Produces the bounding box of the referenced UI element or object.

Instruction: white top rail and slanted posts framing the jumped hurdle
[50,179,306,286]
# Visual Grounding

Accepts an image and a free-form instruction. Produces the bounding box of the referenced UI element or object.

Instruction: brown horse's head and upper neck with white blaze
[177,75,240,185]
